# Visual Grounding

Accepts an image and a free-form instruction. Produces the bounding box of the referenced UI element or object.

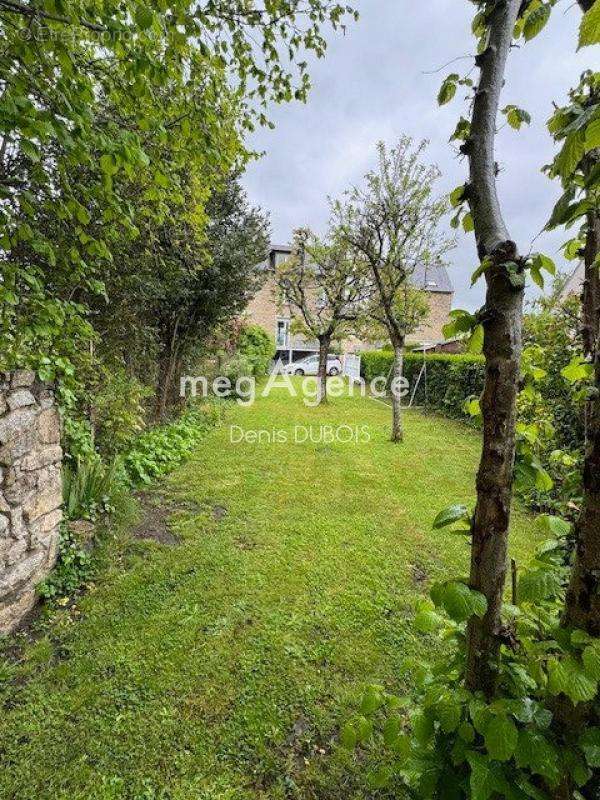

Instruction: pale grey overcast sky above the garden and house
[245,0,600,309]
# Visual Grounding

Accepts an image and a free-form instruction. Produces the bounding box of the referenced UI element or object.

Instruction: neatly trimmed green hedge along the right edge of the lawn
[361,350,485,417]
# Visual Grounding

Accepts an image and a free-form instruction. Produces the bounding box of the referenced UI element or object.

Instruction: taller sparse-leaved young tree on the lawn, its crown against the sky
[333,136,453,442]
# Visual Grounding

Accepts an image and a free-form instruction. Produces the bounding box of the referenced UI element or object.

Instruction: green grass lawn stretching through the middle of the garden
[0,384,534,800]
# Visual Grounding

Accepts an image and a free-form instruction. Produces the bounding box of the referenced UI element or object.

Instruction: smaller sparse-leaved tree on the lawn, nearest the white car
[276,228,368,403]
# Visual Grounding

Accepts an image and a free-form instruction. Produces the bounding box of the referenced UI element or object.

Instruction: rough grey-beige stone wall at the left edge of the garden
[0,370,62,634]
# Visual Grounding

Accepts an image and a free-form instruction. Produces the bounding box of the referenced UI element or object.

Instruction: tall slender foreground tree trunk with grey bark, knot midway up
[463,0,524,697]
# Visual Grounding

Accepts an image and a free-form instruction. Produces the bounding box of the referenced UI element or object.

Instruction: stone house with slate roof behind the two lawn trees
[244,245,454,363]
